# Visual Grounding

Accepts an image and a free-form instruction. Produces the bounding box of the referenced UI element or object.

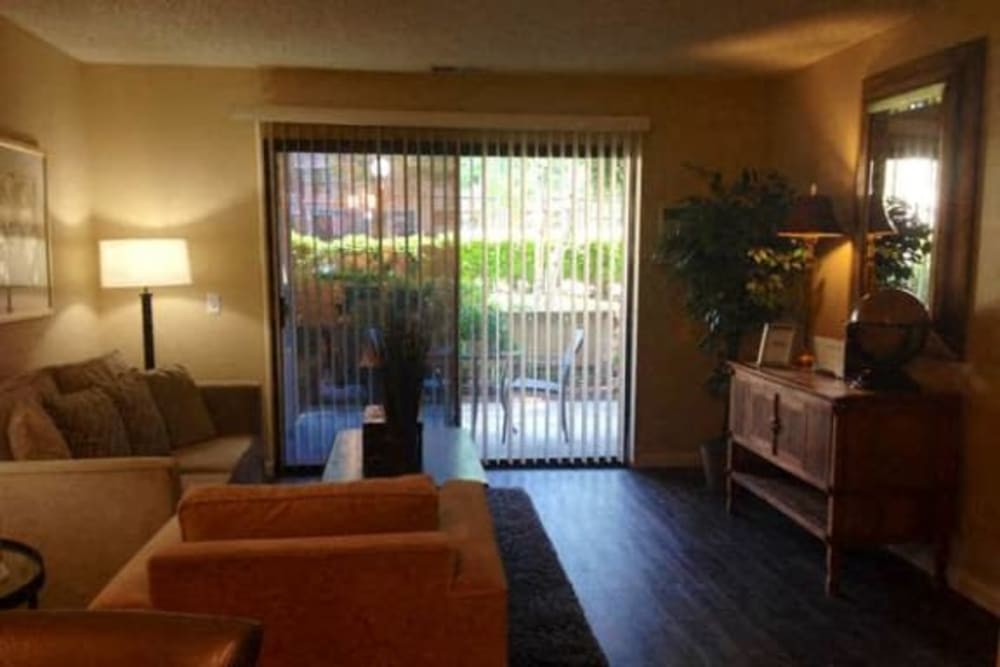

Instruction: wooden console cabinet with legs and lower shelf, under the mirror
[726,363,962,594]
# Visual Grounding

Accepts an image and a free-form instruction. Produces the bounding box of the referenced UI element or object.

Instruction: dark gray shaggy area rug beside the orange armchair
[487,488,608,667]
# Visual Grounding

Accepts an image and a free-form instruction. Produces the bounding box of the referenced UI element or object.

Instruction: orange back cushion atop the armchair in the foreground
[177,475,438,542]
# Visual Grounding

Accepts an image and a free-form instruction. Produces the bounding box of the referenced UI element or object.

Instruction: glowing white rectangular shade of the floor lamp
[100,239,191,287]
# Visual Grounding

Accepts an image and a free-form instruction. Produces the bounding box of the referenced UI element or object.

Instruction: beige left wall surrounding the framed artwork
[0,20,100,378]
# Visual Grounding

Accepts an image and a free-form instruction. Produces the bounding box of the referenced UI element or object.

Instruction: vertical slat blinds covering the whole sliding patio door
[261,123,641,465]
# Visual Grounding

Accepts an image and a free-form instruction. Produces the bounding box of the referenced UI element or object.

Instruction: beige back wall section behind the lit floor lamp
[84,66,266,381]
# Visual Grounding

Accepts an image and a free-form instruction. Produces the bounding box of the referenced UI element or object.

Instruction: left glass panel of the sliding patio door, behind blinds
[263,124,458,467]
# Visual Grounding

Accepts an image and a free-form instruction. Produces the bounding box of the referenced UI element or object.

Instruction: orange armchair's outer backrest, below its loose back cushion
[148,532,454,665]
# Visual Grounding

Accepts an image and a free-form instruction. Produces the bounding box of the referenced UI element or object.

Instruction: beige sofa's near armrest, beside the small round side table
[0,457,180,608]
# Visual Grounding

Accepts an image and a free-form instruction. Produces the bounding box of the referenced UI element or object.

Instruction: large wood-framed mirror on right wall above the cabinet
[855,40,986,357]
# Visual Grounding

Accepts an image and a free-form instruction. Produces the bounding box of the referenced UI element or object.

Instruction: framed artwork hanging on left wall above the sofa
[0,139,52,323]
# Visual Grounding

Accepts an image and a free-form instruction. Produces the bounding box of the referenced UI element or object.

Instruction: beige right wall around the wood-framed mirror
[771,0,1000,613]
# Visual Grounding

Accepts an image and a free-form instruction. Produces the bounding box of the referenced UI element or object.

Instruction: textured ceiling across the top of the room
[0,0,923,73]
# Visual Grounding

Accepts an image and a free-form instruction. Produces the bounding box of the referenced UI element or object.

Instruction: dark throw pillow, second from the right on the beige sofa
[100,368,170,456]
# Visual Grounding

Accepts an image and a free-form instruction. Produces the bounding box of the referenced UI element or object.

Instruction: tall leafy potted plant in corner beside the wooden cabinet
[656,166,806,489]
